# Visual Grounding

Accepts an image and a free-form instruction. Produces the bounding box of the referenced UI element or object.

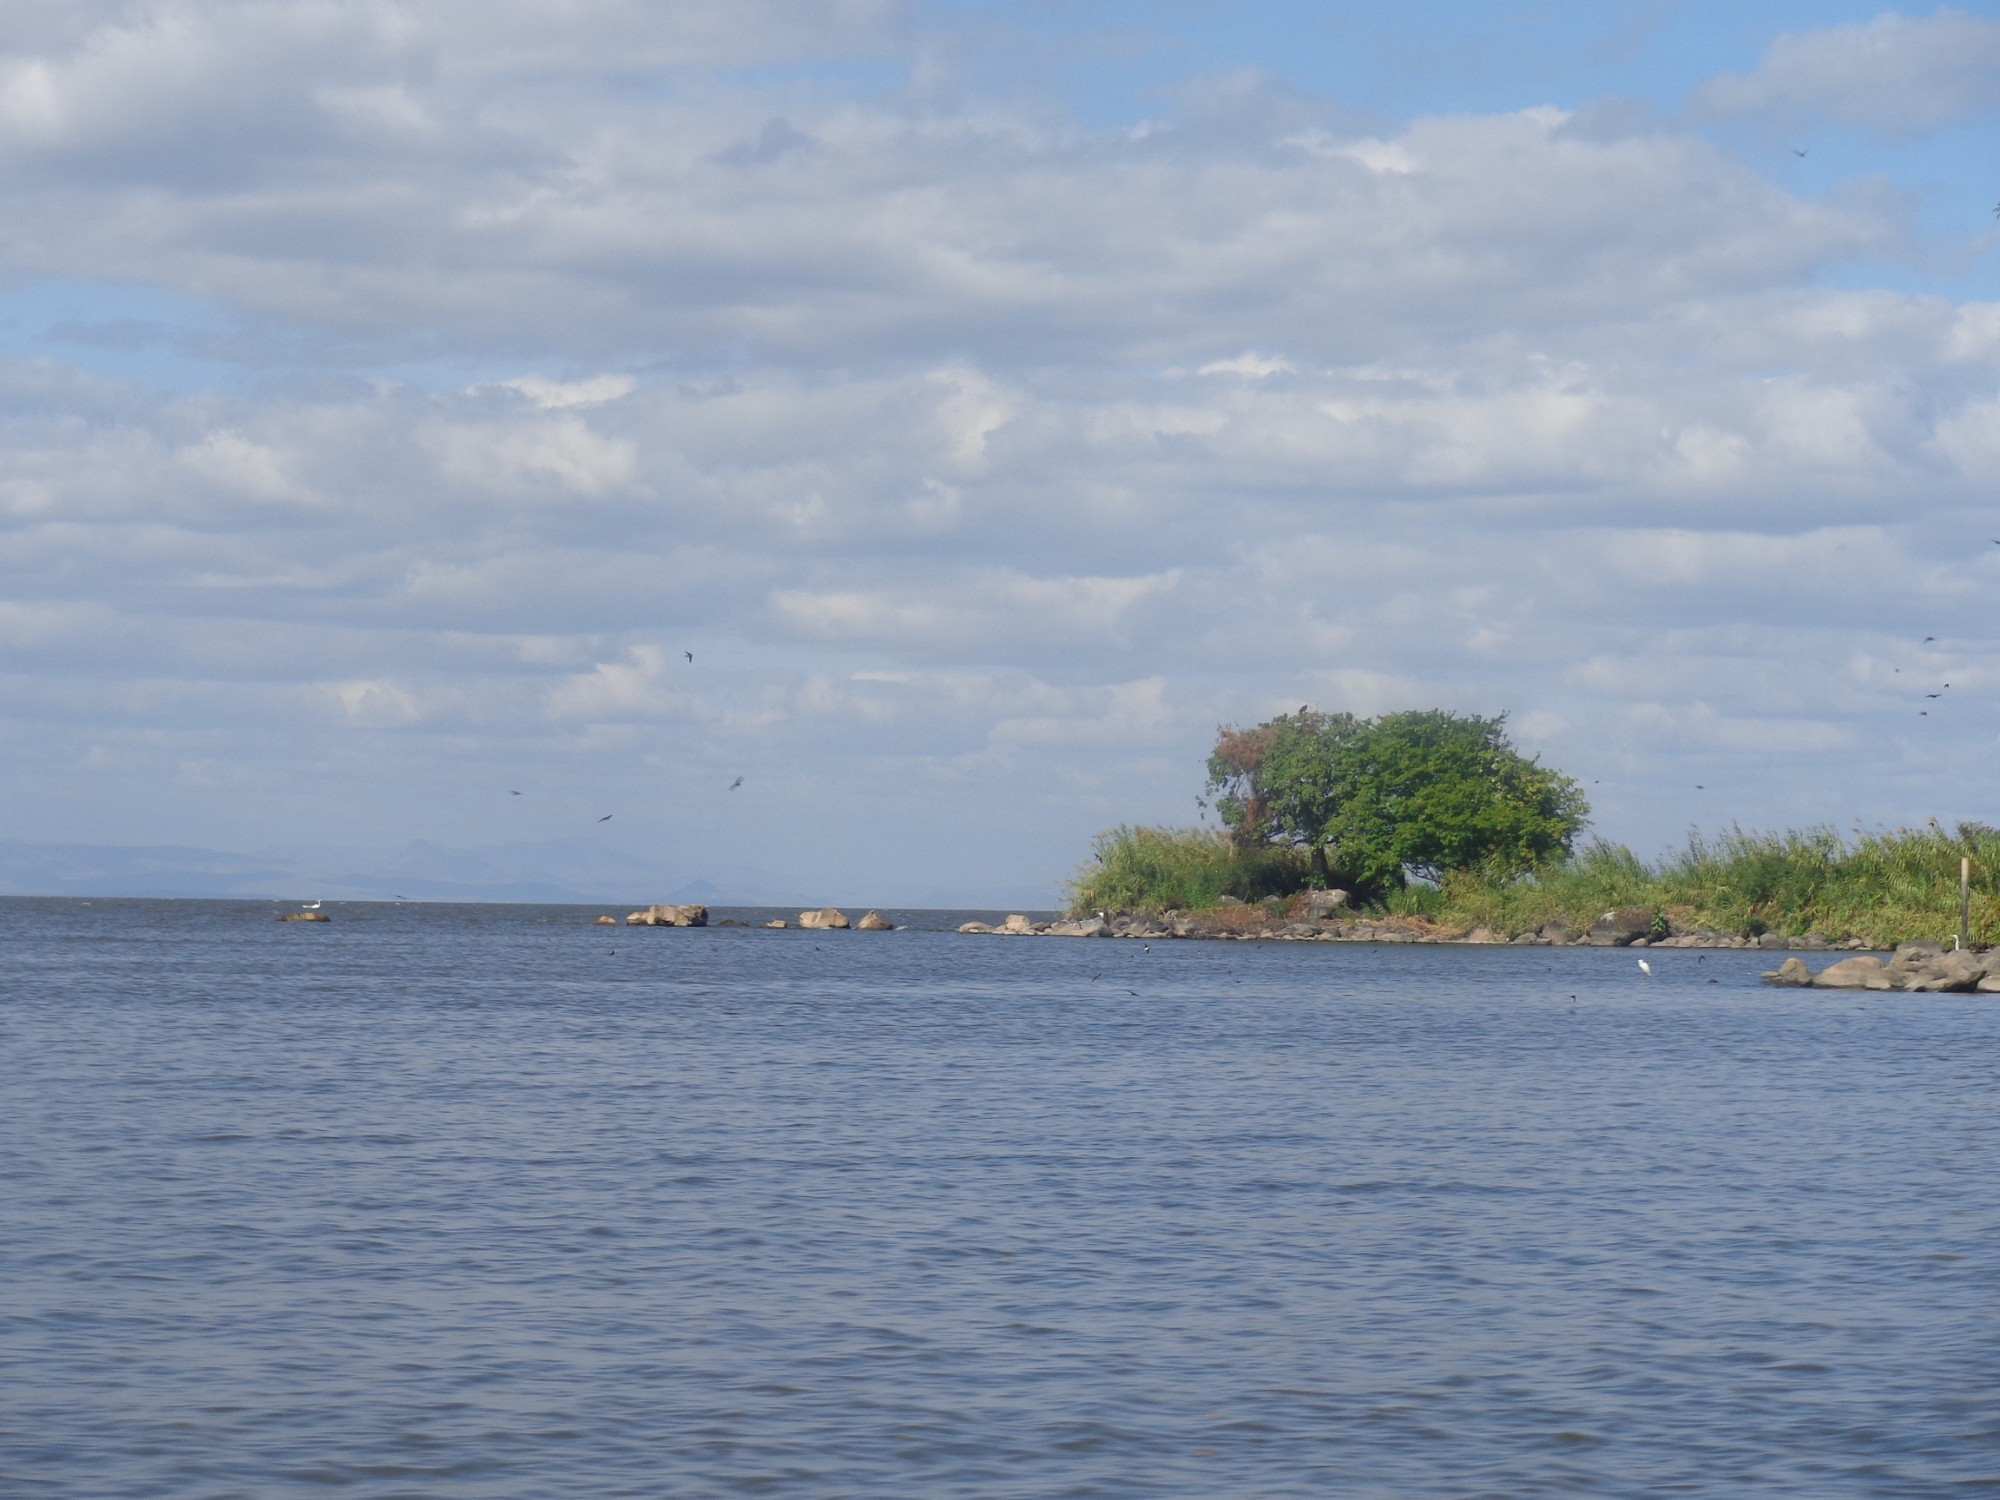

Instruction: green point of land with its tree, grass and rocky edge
[1056,706,2000,964]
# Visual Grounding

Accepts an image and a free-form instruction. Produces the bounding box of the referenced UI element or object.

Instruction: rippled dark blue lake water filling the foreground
[0,900,2000,1498]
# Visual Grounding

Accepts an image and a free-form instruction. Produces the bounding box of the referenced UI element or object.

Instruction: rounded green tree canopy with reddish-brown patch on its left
[1206,708,1590,894]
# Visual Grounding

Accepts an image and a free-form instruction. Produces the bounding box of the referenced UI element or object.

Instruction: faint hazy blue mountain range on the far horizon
[0,840,828,906]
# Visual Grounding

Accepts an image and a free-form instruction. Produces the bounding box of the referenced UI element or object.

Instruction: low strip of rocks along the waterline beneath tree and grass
[958,892,1872,952]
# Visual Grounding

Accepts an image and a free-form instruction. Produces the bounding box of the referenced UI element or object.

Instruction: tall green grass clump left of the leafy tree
[1068,826,1306,912]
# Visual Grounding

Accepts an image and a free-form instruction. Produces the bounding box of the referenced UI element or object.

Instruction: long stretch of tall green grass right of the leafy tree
[1388,824,2000,944]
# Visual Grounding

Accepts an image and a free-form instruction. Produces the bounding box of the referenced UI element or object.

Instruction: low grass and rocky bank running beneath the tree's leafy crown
[1068,822,2000,950]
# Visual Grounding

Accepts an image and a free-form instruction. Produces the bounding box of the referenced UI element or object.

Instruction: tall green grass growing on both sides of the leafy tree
[1070,824,2000,944]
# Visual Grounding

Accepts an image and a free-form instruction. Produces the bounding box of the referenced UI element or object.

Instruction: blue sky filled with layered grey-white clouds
[0,0,2000,904]
